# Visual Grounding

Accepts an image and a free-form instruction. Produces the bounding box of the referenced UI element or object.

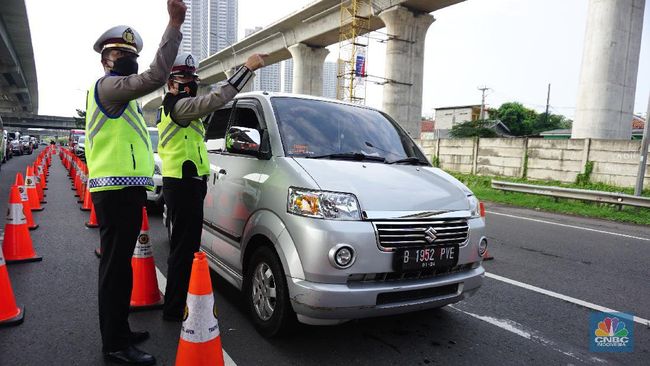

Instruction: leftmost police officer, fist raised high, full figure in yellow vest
[86,0,187,365]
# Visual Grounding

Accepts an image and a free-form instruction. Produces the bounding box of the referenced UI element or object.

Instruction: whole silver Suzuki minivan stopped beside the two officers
[166,92,487,336]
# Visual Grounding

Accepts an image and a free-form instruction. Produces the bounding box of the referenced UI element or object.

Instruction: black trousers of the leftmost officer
[91,187,147,352]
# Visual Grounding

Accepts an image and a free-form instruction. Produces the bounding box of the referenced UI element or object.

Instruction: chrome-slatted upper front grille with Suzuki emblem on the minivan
[374,219,469,250]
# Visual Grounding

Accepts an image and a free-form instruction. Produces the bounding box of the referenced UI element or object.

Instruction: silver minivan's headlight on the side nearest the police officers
[287,187,361,220]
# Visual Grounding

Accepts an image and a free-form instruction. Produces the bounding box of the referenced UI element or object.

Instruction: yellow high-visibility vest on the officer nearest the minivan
[158,107,210,178]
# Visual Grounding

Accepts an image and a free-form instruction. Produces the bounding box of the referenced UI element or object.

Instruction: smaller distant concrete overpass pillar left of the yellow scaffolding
[289,43,329,96]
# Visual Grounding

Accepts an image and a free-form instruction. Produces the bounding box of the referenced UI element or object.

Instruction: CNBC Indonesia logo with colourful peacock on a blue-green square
[590,313,634,352]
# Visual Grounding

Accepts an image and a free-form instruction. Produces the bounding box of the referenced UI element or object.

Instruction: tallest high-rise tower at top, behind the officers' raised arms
[180,0,237,60]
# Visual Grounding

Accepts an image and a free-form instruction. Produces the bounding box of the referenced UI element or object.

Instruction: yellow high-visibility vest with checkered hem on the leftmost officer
[85,83,154,192]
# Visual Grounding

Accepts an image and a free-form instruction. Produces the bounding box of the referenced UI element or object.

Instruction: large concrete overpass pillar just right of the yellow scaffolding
[379,6,435,139]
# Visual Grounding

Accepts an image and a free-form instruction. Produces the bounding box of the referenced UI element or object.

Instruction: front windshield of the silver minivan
[271,97,428,165]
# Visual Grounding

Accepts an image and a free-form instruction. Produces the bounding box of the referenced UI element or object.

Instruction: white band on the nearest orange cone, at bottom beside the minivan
[181,293,220,343]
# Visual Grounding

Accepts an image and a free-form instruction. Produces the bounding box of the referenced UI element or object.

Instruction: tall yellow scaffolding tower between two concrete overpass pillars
[336,0,370,104]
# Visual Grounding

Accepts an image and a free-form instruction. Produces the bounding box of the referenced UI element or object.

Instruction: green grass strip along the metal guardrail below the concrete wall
[450,173,650,225]
